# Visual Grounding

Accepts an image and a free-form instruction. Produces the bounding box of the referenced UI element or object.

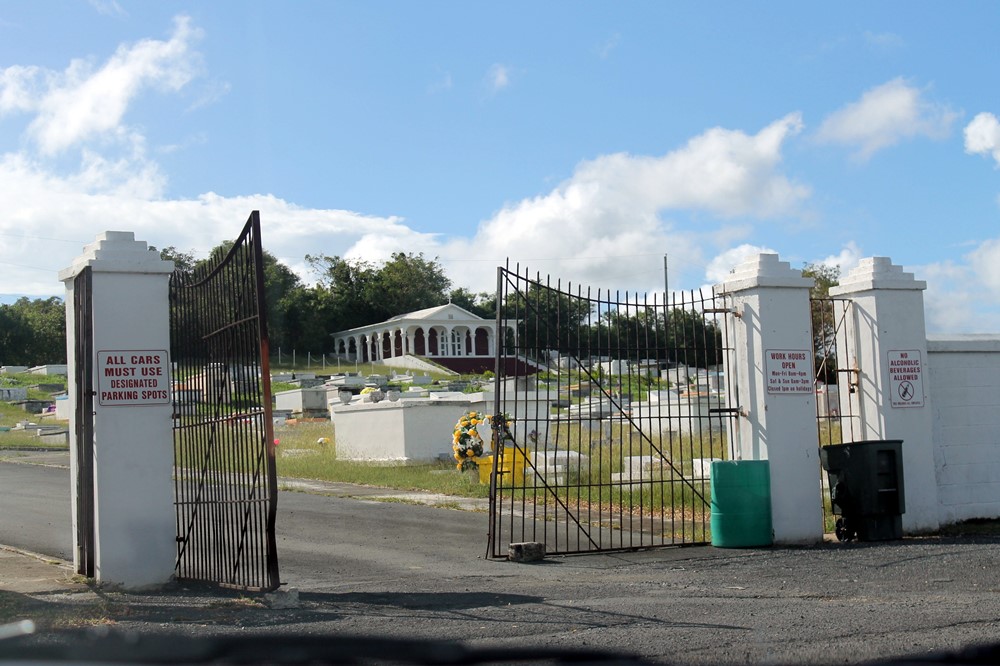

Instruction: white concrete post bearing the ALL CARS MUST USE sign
[59,231,177,588]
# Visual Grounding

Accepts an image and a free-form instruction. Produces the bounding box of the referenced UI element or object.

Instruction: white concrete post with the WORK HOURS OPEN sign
[718,254,823,544]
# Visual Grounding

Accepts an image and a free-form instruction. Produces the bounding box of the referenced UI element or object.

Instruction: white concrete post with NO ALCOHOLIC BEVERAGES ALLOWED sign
[830,257,939,533]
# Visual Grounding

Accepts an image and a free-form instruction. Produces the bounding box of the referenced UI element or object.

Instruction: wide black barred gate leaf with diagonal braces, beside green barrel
[489,268,739,557]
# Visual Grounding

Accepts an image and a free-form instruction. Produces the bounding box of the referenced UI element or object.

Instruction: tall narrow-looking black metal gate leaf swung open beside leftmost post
[170,211,279,590]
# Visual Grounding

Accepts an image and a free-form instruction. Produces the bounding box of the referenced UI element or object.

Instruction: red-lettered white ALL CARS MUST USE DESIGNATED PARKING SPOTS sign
[97,349,170,407]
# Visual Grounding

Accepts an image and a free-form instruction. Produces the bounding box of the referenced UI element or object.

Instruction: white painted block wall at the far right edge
[927,335,1000,523]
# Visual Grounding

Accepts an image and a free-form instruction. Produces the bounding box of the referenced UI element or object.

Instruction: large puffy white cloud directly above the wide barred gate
[442,113,810,290]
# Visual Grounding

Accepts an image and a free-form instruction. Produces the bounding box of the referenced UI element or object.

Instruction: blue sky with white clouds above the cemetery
[0,0,1000,332]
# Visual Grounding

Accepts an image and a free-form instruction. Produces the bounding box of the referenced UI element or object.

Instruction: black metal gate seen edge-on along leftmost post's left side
[73,266,97,578]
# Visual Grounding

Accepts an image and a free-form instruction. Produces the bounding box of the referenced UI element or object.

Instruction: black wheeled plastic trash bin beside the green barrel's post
[820,439,906,541]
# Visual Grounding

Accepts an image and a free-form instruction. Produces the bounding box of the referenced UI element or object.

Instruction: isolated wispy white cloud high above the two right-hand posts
[816,78,958,160]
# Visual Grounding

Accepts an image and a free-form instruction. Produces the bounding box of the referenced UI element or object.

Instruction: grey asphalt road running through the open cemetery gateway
[0,454,1000,664]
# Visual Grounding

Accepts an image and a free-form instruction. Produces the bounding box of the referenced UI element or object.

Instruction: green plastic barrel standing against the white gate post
[711,460,774,548]
